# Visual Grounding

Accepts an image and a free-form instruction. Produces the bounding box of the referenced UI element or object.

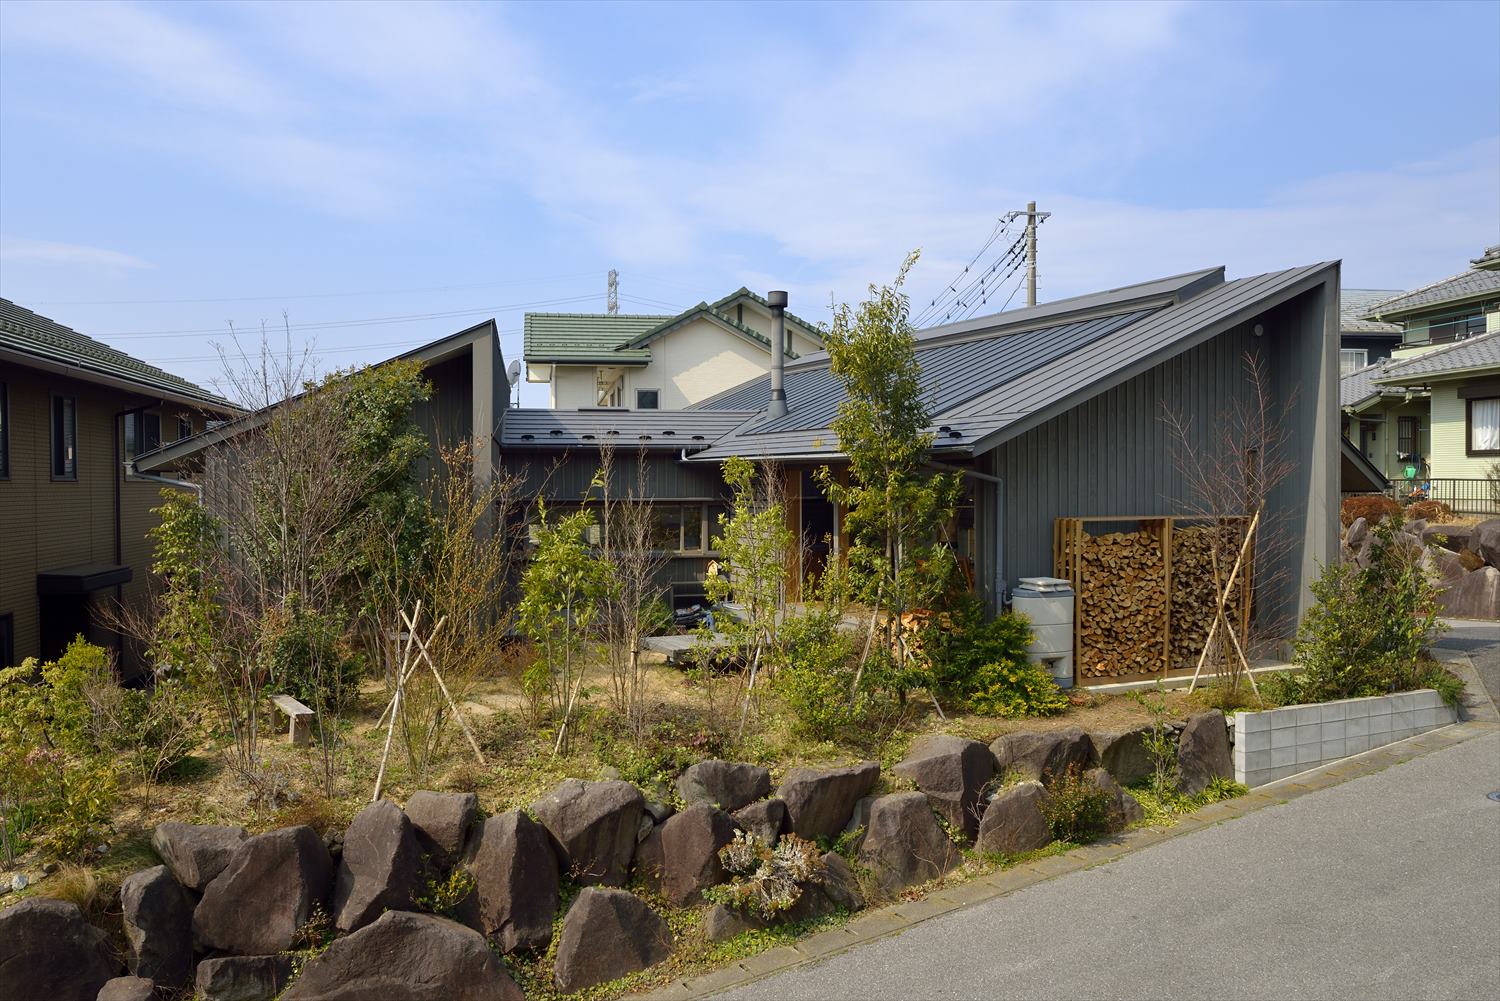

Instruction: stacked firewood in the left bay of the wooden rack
[1073,528,1167,678]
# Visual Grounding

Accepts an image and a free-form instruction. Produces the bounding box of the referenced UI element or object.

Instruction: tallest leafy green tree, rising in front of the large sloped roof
[819,252,960,696]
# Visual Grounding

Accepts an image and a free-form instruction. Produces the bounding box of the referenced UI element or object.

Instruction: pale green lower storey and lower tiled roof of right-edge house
[1371,330,1500,503]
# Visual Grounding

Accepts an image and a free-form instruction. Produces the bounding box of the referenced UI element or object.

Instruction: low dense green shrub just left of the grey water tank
[921,594,1031,711]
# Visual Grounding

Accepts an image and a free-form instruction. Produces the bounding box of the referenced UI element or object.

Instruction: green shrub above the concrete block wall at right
[1269,512,1443,705]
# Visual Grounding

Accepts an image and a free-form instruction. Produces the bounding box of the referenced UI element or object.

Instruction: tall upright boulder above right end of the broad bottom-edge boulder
[464,810,560,953]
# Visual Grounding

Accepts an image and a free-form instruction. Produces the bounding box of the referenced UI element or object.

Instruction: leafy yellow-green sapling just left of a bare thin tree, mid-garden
[521,501,609,753]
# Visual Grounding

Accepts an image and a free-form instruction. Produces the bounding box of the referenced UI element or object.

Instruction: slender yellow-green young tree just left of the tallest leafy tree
[705,456,792,734]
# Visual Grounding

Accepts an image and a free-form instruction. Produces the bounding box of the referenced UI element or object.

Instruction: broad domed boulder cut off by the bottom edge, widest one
[282,911,525,1001]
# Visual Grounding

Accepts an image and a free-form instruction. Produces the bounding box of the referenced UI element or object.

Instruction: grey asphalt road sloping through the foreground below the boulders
[719,734,1500,1001]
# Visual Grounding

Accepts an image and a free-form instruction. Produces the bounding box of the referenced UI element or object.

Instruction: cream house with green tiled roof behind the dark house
[524,288,822,410]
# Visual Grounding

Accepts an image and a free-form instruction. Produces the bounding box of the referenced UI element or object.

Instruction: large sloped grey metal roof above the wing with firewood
[693,263,1337,459]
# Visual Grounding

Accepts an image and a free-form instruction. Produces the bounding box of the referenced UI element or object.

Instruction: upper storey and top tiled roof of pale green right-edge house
[1364,245,1500,351]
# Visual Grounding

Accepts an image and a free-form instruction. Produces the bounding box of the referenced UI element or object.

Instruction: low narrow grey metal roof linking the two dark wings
[500,407,756,452]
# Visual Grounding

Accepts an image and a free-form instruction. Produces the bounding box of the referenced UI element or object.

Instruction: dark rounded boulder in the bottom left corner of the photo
[0,897,120,1001]
